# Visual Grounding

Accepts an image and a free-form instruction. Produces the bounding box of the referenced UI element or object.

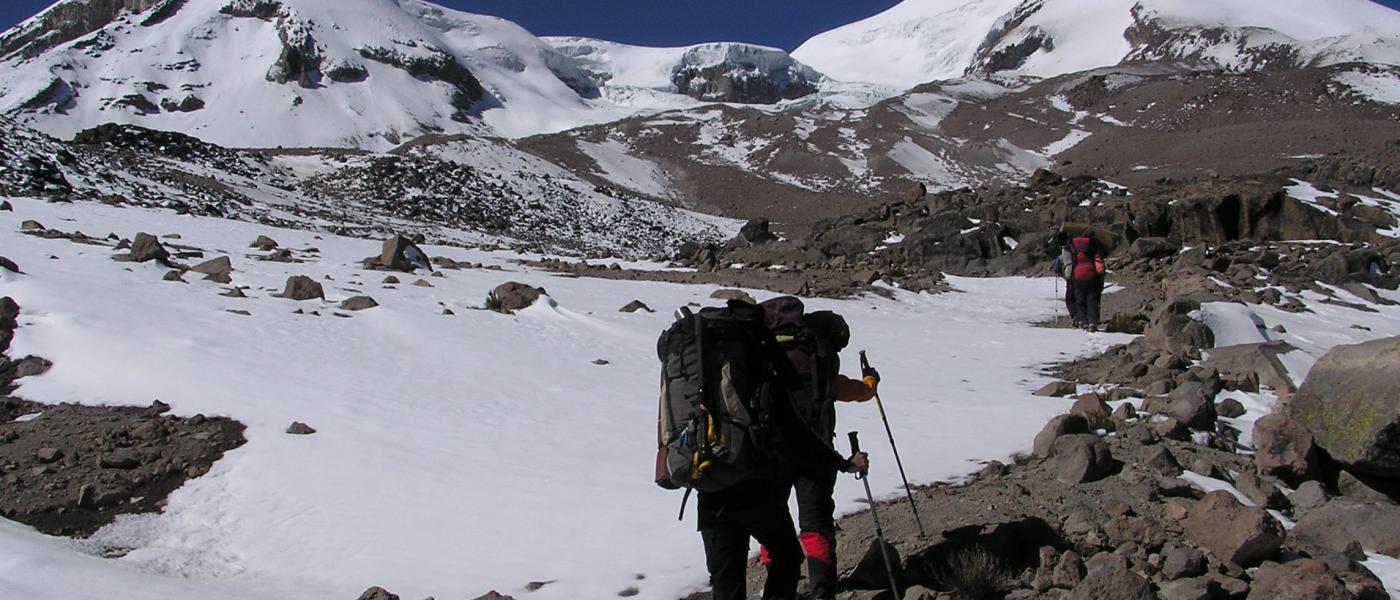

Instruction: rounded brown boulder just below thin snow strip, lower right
[1182,491,1284,568]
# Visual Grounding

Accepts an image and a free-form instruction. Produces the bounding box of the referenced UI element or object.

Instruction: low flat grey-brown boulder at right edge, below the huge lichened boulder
[1288,498,1400,558]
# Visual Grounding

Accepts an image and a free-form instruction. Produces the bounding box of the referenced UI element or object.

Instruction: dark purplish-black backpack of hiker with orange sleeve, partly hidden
[760,297,851,445]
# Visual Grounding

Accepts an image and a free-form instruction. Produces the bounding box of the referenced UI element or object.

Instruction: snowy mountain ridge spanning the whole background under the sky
[0,0,1400,150]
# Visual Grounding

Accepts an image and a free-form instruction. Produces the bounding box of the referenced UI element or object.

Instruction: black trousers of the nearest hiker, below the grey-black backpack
[696,487,802,600]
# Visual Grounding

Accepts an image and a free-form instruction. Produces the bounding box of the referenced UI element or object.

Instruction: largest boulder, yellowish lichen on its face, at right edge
[1287,336,1400,478]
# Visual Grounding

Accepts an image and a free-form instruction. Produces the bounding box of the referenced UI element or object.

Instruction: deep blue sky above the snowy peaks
[0,0,1400,50]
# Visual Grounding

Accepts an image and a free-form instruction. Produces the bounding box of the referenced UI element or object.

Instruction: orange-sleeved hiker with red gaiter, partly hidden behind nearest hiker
[760,297,879,600]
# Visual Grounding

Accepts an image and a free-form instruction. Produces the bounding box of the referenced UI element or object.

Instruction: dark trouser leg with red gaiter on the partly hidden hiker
[784,470,837,600]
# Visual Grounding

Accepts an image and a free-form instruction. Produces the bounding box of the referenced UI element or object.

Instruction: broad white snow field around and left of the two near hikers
[0,199,1126,600]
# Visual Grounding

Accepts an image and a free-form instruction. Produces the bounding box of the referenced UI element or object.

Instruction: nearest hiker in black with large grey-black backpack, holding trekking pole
[657,301,869,600]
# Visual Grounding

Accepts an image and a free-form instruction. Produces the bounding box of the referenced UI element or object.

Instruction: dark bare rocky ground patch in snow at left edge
[0,297,244,537]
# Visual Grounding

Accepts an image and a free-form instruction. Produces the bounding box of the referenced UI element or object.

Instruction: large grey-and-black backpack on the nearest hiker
[655,301,778,492]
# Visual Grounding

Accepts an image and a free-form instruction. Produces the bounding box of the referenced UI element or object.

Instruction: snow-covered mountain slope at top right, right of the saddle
[792,0,1400,88]
